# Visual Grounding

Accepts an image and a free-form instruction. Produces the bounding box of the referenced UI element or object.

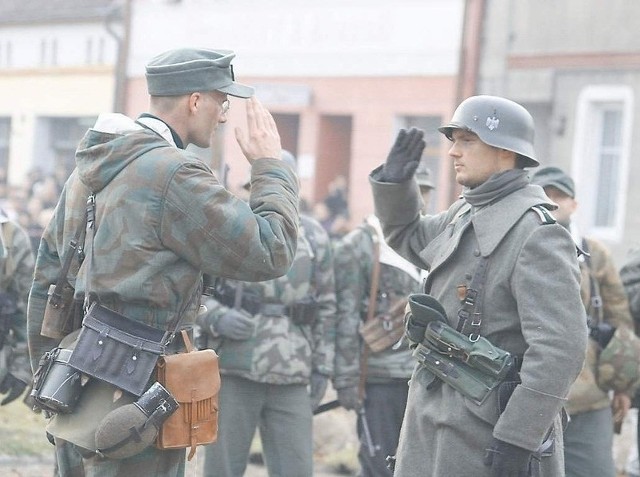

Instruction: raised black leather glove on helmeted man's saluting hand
[380,128,426,183]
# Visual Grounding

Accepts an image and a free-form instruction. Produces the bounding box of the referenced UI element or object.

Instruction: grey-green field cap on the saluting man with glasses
[145,48,254,98]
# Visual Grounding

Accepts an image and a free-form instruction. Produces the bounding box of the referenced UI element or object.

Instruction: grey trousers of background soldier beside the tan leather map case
[204,375,313,477]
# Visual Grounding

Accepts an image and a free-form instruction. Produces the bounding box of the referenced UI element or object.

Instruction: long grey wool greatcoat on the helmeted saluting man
[371,171,587,477]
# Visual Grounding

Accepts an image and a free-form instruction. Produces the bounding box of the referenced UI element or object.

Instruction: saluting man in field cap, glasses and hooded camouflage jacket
[27,49,298,477]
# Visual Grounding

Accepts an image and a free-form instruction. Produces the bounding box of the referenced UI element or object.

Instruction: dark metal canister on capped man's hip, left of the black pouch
[30,348,83,414]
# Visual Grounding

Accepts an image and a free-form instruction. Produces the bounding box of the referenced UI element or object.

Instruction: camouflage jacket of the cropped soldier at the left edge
[0,216,34,384]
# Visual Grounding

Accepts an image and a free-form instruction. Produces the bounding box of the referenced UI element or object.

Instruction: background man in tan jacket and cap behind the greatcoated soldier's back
[531,167,637,477]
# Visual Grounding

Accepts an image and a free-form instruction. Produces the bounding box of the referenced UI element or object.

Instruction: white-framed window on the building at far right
[572,86,633,242]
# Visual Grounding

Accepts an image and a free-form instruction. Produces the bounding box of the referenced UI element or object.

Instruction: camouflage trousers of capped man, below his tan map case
[54,438,185,477]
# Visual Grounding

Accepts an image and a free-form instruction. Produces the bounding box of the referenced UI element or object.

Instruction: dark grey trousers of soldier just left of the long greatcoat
[358,379,409,477]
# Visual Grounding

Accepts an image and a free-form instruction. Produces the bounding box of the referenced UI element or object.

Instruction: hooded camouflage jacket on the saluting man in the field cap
[27,115,298,369]
